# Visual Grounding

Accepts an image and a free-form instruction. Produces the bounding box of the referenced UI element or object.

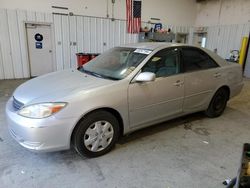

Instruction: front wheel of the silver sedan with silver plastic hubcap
[72,110,119,158]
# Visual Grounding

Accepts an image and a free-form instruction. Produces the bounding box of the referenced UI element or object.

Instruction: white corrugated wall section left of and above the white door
[0,9,53,79]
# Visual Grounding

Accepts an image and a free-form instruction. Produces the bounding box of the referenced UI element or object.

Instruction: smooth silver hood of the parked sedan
[13,69,115,104]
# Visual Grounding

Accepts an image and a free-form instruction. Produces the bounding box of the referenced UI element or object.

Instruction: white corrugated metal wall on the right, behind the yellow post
[206,24,250,58]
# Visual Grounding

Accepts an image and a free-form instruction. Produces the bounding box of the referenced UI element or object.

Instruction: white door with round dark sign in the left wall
[26,24,53,77]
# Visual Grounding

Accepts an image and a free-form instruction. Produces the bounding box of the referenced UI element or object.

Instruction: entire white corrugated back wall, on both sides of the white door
[0,9,193,79]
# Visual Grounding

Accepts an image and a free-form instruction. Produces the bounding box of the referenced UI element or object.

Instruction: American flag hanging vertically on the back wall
[126,0,141,33]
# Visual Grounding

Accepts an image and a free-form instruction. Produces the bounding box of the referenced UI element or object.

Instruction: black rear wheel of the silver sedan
[205,88,229,118]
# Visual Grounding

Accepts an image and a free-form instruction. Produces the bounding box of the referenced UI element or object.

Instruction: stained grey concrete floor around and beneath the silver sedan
[0,80,250,188]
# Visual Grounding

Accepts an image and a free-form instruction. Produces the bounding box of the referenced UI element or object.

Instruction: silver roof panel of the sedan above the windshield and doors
[121,42,191,50]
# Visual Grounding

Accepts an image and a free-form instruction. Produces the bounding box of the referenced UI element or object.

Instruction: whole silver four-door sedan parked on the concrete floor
[6,43,243,157]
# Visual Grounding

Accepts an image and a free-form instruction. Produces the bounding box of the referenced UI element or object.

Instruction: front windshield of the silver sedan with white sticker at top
[79,47,152,80]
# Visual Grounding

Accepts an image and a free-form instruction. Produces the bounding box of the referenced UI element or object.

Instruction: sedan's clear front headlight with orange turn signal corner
[18,102,66,119]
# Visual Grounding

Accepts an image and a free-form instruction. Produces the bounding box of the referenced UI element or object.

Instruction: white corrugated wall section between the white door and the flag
[53,14,144,70]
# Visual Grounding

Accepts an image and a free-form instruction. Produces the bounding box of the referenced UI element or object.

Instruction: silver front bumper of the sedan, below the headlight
[6,98,76,152]
